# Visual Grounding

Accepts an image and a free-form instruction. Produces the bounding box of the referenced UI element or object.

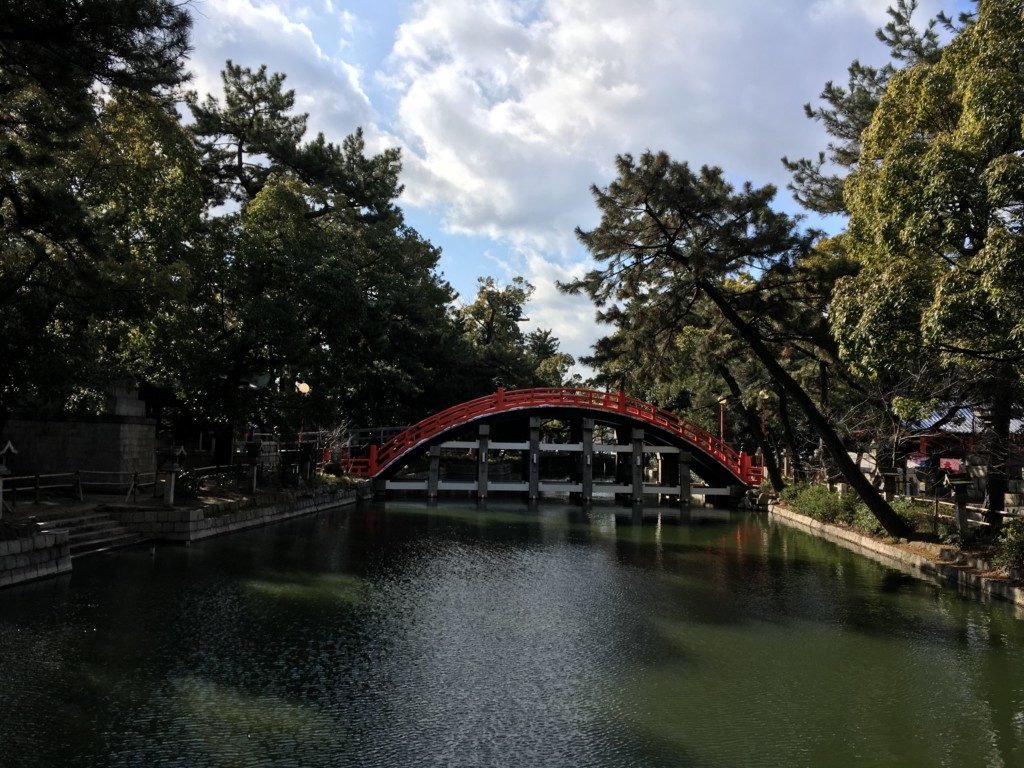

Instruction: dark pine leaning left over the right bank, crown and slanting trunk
[565,153,907,536]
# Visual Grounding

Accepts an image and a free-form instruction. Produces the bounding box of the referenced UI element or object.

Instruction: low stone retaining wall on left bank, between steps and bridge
[104,483,369,542]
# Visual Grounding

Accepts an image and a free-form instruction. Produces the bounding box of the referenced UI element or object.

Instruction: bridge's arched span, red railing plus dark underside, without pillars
[346,387,764,485]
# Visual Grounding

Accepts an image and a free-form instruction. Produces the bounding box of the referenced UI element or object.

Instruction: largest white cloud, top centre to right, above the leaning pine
[389,0,950,254]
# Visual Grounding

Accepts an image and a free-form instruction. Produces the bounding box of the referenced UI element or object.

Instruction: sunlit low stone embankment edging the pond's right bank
[769,503,1024,610]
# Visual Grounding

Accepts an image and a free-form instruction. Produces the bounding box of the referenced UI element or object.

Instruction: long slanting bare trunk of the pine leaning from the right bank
[696,280,912,537]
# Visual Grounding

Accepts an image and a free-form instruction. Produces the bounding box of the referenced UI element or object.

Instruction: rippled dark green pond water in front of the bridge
[0,504,1024,768]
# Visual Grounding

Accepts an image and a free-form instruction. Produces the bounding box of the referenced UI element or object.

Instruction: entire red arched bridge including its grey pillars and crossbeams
[342,387,764,507]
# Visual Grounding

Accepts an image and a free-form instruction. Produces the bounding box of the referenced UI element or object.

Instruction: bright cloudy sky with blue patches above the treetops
[182,0,955,364]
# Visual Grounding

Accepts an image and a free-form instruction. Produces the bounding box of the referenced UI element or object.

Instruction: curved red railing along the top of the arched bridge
[341,387,764,485]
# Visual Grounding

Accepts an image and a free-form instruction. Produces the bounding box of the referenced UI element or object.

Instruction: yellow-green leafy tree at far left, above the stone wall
[0,89,203,421]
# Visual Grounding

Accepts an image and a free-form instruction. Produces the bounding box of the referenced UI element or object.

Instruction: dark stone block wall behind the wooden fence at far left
[0,416,157,475]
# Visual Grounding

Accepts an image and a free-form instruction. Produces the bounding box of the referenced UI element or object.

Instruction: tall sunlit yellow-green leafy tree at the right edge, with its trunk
[835,0,1024,524]
